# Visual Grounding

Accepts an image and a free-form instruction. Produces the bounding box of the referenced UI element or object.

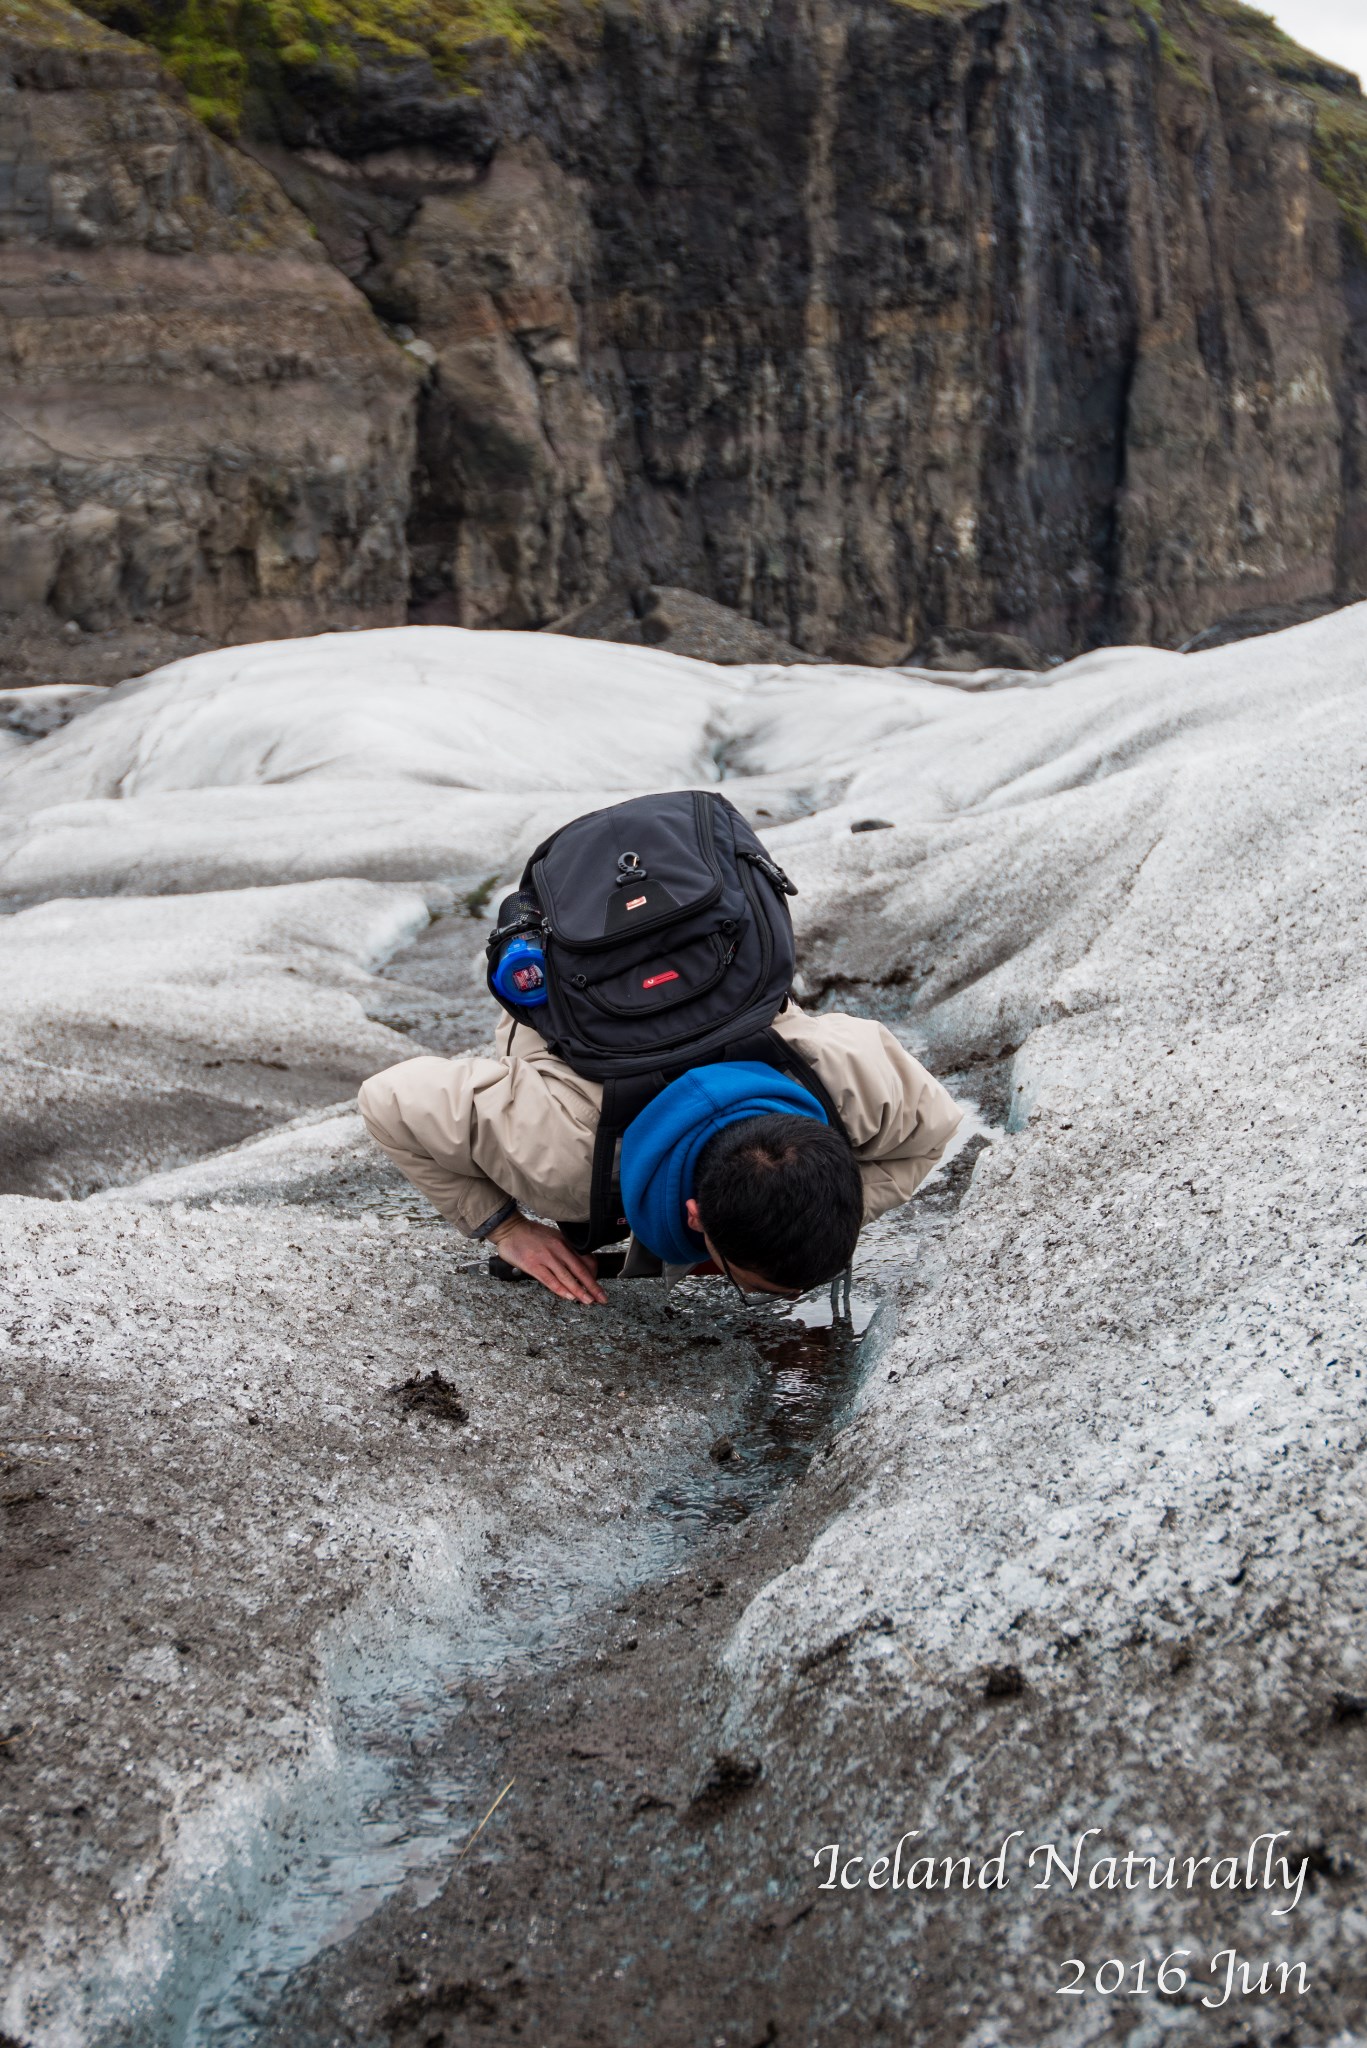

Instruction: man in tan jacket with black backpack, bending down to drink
[361,791,959,1303]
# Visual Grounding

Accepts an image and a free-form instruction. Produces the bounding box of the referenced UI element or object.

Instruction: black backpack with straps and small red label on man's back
[488,788,842,1251]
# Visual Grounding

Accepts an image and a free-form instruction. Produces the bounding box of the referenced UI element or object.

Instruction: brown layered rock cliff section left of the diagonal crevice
[0,0,418,676]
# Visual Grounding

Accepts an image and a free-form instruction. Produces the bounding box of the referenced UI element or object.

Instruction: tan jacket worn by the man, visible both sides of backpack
[361,1006,959,1237]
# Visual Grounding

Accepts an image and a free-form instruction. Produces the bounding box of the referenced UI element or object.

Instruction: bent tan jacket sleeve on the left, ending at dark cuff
[359,1057,514,1237]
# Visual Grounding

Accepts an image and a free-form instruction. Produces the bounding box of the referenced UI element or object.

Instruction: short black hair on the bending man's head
[693,1116,863,1288]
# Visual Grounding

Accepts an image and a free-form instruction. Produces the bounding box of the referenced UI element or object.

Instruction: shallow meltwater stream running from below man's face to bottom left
[92,1282,894,2048]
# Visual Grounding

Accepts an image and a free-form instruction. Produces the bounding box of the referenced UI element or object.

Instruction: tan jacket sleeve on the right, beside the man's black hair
[779,1012,963,1223]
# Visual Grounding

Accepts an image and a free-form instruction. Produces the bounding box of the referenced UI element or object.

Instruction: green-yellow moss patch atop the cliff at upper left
[73,0,555,135]
